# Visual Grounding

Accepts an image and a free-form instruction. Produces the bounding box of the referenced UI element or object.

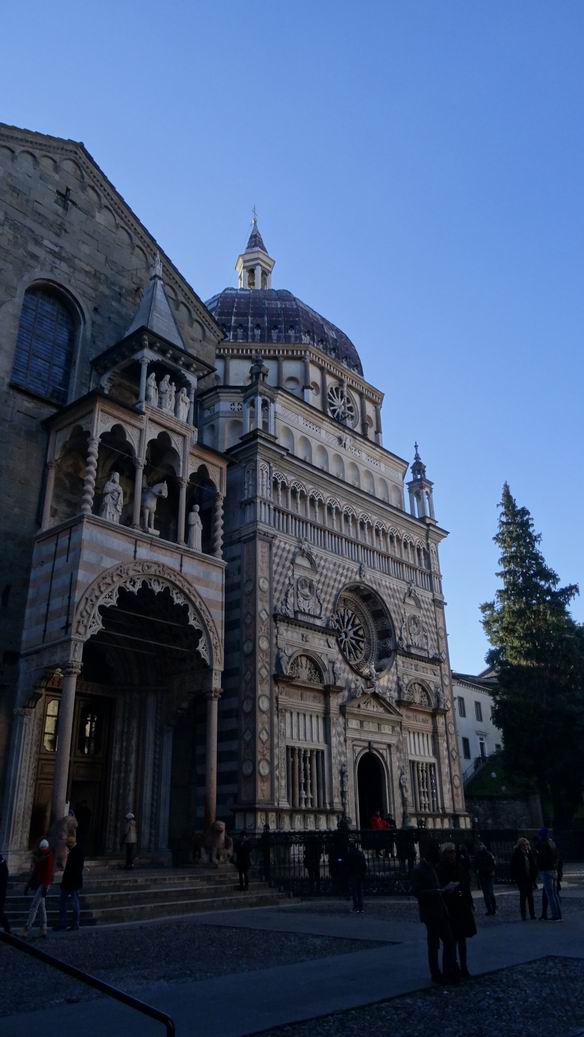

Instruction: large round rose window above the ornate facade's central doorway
[333,586,395,676]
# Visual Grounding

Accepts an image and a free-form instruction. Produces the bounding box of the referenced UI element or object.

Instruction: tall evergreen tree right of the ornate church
[481,483,584,826]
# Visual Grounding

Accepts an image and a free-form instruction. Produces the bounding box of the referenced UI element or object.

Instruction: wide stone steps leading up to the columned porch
[6,862,283,929]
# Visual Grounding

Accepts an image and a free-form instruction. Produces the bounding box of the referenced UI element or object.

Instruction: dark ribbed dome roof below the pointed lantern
[205,288,363,375]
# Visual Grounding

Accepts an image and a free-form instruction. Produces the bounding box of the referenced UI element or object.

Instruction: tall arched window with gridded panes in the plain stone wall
[12,285,77,403]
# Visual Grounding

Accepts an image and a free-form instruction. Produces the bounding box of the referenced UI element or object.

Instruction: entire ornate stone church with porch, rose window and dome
[0,127,467,861]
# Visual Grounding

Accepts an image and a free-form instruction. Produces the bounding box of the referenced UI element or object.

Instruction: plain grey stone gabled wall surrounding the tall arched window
[0,125,218,785]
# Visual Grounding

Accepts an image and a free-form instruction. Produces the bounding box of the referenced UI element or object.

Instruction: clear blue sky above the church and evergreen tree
[0,0,584,672]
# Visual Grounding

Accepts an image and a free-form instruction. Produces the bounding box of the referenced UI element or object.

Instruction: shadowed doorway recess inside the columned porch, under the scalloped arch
[31,577,210,863]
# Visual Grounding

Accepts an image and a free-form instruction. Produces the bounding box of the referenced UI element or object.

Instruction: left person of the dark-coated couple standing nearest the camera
[412,839,458,983]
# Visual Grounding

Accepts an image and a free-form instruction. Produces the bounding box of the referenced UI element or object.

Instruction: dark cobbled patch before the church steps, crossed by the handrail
[0,919,380,1016]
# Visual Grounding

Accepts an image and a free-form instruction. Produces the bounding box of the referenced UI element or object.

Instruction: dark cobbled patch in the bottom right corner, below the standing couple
[254,957,584,1037]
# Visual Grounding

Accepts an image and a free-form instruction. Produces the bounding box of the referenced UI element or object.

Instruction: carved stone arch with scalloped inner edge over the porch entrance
[73,561,223,670]
